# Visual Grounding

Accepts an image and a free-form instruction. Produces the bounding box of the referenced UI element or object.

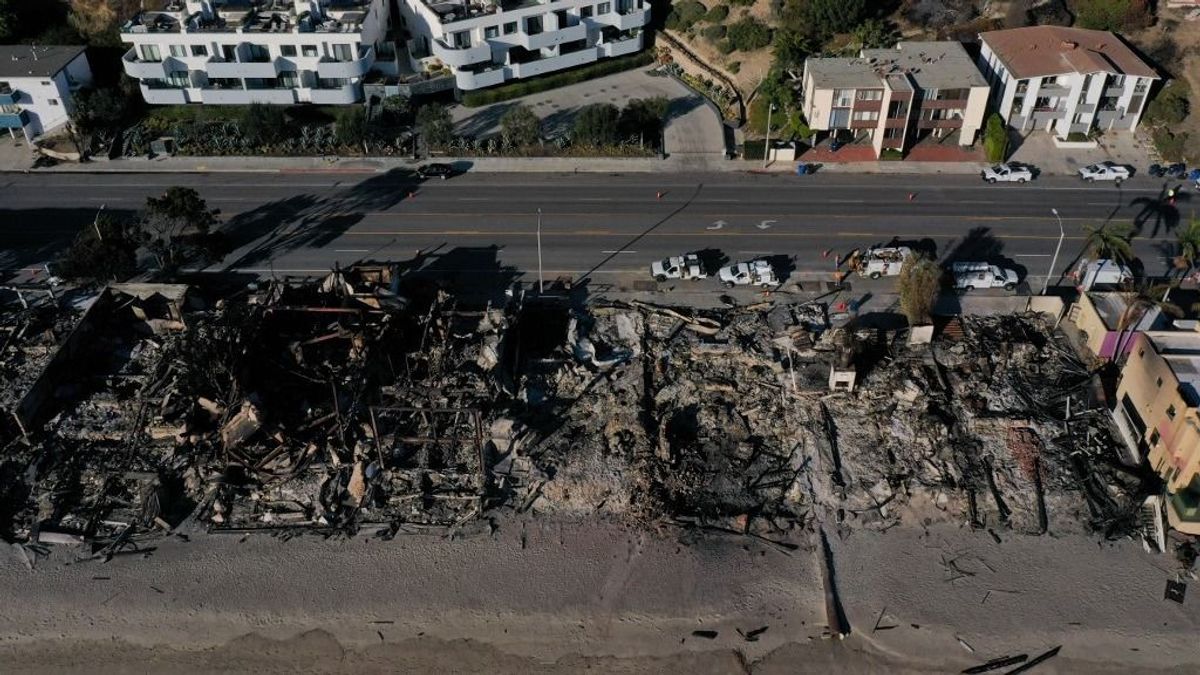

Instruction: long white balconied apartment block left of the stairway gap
[121,0,396,104]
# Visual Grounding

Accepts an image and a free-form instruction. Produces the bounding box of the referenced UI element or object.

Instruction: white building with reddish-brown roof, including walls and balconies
[979,25,1159,138]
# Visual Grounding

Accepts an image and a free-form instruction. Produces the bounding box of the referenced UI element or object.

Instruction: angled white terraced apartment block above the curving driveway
[398,0,650,90]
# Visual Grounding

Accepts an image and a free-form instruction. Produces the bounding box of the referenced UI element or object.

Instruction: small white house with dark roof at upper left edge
[0,44,91,141]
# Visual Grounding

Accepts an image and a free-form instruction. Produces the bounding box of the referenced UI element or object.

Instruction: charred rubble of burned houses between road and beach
[0,265,1142,555]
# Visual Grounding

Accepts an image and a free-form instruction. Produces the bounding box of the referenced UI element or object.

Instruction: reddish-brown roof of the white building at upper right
[979,25,1158,79]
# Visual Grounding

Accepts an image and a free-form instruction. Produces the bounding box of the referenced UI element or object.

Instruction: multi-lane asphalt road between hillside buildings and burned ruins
[0,173,1192,285]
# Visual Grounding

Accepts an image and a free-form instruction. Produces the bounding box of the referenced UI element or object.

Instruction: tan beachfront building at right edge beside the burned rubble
[1114,322,1200,534]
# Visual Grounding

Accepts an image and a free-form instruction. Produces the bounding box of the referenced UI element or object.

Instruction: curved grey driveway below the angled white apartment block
[451,68,725,171]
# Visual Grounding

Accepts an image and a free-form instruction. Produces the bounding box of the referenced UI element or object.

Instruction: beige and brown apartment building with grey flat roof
[803,42,989,156]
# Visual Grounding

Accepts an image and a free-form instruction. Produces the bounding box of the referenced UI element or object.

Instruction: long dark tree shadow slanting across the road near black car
[220,169,420,270]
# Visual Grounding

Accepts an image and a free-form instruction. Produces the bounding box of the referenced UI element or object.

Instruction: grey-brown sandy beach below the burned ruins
[0,518,1200,674]
